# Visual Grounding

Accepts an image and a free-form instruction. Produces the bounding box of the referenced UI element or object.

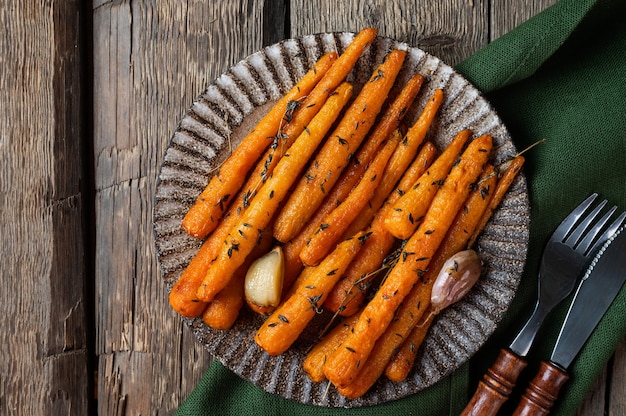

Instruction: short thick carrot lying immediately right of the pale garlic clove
[254,233,366,355]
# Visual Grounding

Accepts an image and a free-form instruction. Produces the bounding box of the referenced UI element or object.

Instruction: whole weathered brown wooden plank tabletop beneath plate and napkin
[0,0,626,416]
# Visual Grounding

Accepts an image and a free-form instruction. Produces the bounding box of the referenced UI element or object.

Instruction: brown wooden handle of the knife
[513,361,569,416]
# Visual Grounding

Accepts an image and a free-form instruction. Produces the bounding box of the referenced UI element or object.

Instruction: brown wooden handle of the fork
[461,349,526,416]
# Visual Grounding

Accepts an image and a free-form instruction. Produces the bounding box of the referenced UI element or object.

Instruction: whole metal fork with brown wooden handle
[461,193,626,416]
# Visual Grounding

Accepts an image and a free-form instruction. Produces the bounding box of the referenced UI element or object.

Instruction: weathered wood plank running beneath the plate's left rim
[93,1,263,414]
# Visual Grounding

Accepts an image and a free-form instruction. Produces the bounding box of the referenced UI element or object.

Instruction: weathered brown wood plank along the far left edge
[0,1,93,415]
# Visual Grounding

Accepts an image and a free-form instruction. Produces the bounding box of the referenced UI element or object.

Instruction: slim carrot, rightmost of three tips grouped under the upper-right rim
[346,89,443,239]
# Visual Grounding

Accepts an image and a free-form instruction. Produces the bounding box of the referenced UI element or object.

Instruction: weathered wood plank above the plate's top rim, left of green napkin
[291,0,489,65]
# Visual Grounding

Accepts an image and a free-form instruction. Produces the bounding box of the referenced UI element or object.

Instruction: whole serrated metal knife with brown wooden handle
[514,227,626,416]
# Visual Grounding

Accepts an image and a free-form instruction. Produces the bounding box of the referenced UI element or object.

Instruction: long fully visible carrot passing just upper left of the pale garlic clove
[197,83,352,302]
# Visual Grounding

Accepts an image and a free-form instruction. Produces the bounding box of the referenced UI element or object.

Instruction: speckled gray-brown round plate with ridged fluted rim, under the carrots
[153,33,529,407]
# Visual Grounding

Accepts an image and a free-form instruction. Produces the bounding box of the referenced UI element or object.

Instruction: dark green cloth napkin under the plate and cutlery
[177,0,626,416]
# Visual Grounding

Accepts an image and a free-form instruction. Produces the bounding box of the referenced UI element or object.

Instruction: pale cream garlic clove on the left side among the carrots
[244,246,285,306]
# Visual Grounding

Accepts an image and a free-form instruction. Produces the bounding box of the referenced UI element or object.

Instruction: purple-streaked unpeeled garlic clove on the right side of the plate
[430,250,482,313]
